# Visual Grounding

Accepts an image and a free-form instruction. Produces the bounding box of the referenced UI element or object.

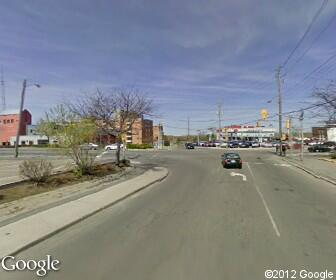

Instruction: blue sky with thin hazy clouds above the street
[0,0,336,134]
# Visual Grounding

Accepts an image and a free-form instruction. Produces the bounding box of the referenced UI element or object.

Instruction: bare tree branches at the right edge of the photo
[312,82,336,122]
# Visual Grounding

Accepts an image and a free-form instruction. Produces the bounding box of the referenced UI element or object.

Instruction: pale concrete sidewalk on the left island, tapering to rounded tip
[0,167,168,258]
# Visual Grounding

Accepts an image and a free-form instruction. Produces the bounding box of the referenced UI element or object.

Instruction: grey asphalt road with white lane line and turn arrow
[0,149,336,280]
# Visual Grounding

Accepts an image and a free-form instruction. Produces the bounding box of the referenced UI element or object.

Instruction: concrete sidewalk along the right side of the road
[283,155,336,185]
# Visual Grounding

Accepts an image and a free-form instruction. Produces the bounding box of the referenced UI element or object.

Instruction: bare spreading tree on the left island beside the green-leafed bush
[70,88,153,164]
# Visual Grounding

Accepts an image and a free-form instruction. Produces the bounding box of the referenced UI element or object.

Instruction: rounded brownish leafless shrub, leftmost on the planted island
[19,159,53,184]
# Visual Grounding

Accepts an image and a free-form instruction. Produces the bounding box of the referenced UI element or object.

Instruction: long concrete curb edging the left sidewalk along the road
[0,165,169,260]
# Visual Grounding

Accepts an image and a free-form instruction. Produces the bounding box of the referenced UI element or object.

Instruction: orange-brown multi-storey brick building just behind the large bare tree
[124,117,153,144]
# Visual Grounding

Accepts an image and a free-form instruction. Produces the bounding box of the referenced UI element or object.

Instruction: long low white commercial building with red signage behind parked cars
[217,125,276,142]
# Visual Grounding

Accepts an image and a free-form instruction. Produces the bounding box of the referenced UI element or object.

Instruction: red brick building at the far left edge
[0,110,32,146]
